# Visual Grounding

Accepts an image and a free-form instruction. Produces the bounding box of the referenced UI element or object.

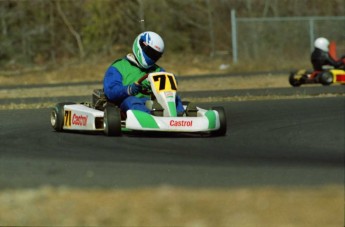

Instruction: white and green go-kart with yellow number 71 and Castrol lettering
[50,72,227,136]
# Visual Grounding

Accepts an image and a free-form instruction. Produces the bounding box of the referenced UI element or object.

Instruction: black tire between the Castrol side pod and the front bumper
[103,105,121,136]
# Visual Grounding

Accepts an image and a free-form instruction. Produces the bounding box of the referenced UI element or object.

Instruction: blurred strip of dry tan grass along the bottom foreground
[0,186,344,227]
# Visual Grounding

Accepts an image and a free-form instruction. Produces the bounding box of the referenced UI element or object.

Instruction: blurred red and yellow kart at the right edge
[289,42,345,87]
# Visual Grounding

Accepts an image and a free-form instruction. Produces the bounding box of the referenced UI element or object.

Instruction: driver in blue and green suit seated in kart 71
[103,31,196,116]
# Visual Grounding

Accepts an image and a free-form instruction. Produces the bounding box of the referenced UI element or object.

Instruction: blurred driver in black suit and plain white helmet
[311,37,345,71]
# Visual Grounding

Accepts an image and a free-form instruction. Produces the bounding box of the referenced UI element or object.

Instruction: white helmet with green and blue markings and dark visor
[132,31,164,69]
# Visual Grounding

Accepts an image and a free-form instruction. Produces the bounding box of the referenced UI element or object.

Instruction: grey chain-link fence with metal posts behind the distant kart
[231,10,345,67]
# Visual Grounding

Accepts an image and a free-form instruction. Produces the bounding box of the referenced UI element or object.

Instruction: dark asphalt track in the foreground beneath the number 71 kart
[0,97,345,188]
